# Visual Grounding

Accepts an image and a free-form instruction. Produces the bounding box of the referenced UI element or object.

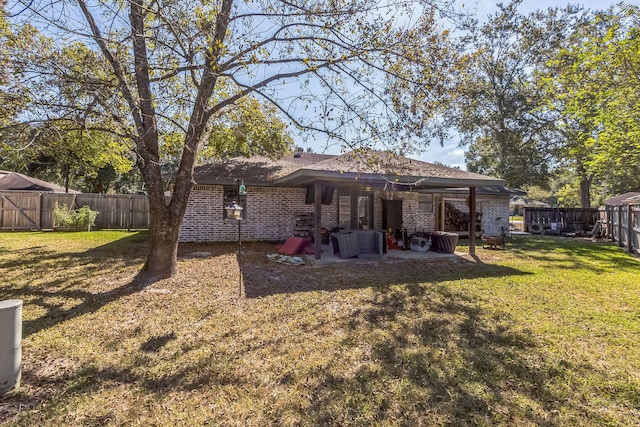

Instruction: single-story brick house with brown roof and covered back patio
[180,151,510,257]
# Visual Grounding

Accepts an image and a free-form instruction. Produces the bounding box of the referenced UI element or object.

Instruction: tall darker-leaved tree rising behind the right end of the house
[448,0,581,187]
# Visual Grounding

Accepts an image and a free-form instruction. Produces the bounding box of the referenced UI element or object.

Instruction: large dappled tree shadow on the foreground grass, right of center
[291,283,612,425]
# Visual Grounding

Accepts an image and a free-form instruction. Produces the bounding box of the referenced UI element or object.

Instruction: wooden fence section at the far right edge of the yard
[600,204,640,254]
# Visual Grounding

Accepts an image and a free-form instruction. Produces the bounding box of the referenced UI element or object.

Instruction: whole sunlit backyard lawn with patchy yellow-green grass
[0,232,640,426]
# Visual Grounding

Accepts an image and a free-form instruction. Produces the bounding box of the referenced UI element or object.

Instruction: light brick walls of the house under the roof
[180,185,509,242]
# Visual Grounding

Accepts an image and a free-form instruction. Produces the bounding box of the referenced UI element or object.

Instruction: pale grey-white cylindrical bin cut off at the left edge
[0,299,22,395]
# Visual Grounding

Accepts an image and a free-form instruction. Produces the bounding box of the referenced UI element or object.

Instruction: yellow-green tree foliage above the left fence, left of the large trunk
[0,25,133,191]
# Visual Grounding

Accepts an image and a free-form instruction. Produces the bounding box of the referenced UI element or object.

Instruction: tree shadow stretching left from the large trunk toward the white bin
[0,232,149,338]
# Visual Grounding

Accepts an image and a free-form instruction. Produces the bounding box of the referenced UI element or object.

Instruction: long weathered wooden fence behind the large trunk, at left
[0,191,149,230]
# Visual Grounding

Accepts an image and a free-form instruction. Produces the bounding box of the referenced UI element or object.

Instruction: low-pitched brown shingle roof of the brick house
[194,151,504,189]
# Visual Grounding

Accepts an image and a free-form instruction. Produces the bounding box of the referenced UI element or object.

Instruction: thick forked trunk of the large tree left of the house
[78,0,233,283]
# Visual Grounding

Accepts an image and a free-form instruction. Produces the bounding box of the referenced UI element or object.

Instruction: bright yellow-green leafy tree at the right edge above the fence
[540,6,640,207]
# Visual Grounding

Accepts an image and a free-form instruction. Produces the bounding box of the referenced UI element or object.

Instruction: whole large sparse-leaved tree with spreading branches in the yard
[7,0,452,280]
